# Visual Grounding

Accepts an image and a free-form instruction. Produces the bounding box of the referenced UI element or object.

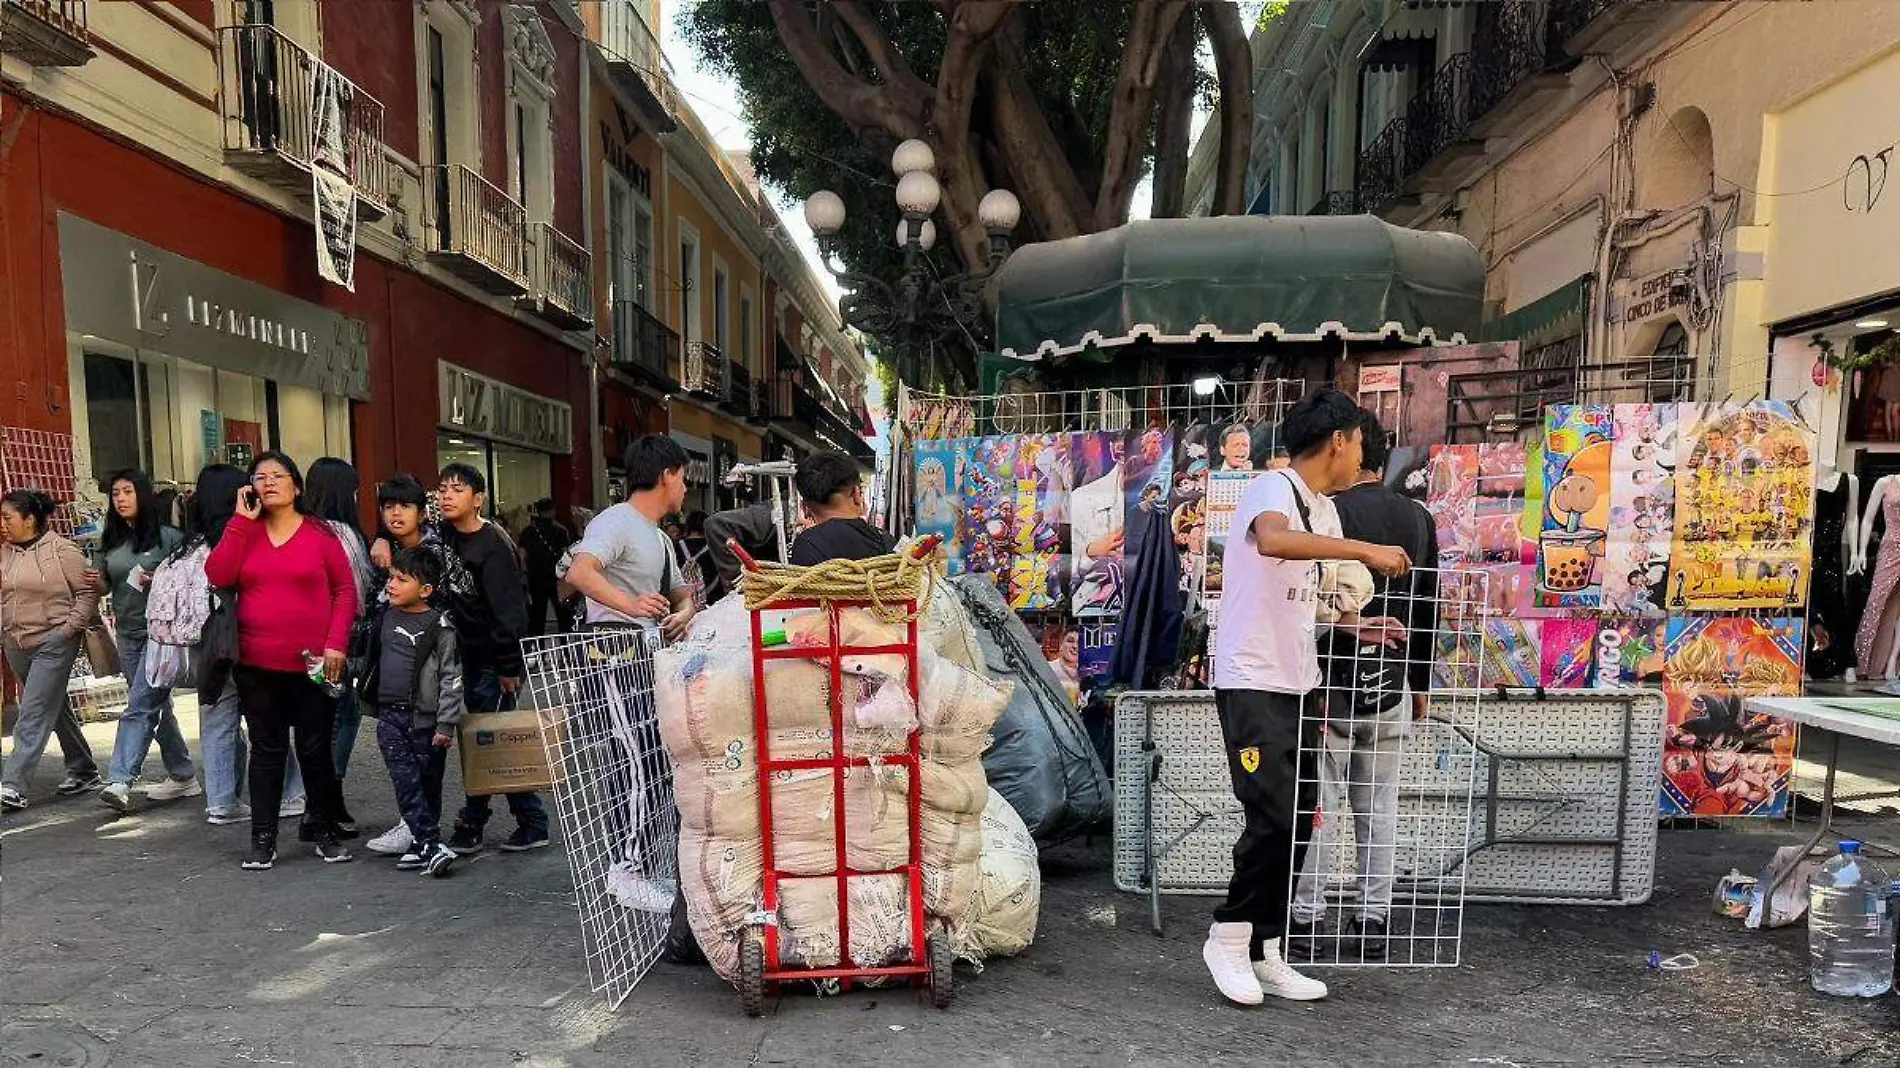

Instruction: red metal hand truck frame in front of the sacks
[728,536,939,988]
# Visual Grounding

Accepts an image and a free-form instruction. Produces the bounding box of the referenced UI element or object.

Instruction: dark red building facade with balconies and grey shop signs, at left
[0,0,595,521]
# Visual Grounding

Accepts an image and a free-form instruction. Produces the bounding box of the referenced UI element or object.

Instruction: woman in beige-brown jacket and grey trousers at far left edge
[0,490,99,810]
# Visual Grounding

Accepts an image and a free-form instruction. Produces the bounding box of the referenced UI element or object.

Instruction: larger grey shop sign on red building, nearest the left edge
[59,213,369,401]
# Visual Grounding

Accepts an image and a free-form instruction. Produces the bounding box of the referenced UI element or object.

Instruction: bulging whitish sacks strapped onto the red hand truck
[654,597,1010,981]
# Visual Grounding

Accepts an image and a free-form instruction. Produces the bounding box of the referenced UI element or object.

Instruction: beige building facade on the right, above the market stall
[1189,0,1900,456]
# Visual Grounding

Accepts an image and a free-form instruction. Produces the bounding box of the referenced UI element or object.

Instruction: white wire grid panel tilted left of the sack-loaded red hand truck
[521,627,678,1007]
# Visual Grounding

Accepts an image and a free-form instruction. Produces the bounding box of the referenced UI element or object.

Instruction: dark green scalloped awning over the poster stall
[996,215,1484,361]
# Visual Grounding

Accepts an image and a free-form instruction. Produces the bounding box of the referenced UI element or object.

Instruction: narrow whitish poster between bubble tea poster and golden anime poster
[1602,405,1676,616]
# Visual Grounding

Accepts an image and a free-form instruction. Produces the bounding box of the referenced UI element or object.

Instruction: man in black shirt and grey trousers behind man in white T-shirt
[1286,412,1438,963]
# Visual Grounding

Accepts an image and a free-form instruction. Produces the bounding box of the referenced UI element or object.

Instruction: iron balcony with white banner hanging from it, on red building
[219,25,395,220]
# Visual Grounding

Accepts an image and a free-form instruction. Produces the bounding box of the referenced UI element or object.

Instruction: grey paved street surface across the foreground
[0,716,1900,1066]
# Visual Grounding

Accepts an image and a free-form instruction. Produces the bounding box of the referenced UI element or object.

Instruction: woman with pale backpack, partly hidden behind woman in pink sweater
[183,464,304,827]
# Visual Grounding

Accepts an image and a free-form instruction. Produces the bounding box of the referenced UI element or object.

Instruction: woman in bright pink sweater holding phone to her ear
[205,450,357,870]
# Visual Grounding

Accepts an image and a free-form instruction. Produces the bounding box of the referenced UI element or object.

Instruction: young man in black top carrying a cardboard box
[435,464,547,857]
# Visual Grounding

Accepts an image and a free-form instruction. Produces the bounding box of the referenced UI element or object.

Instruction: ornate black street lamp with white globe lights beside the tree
[806,141,1022,382]
